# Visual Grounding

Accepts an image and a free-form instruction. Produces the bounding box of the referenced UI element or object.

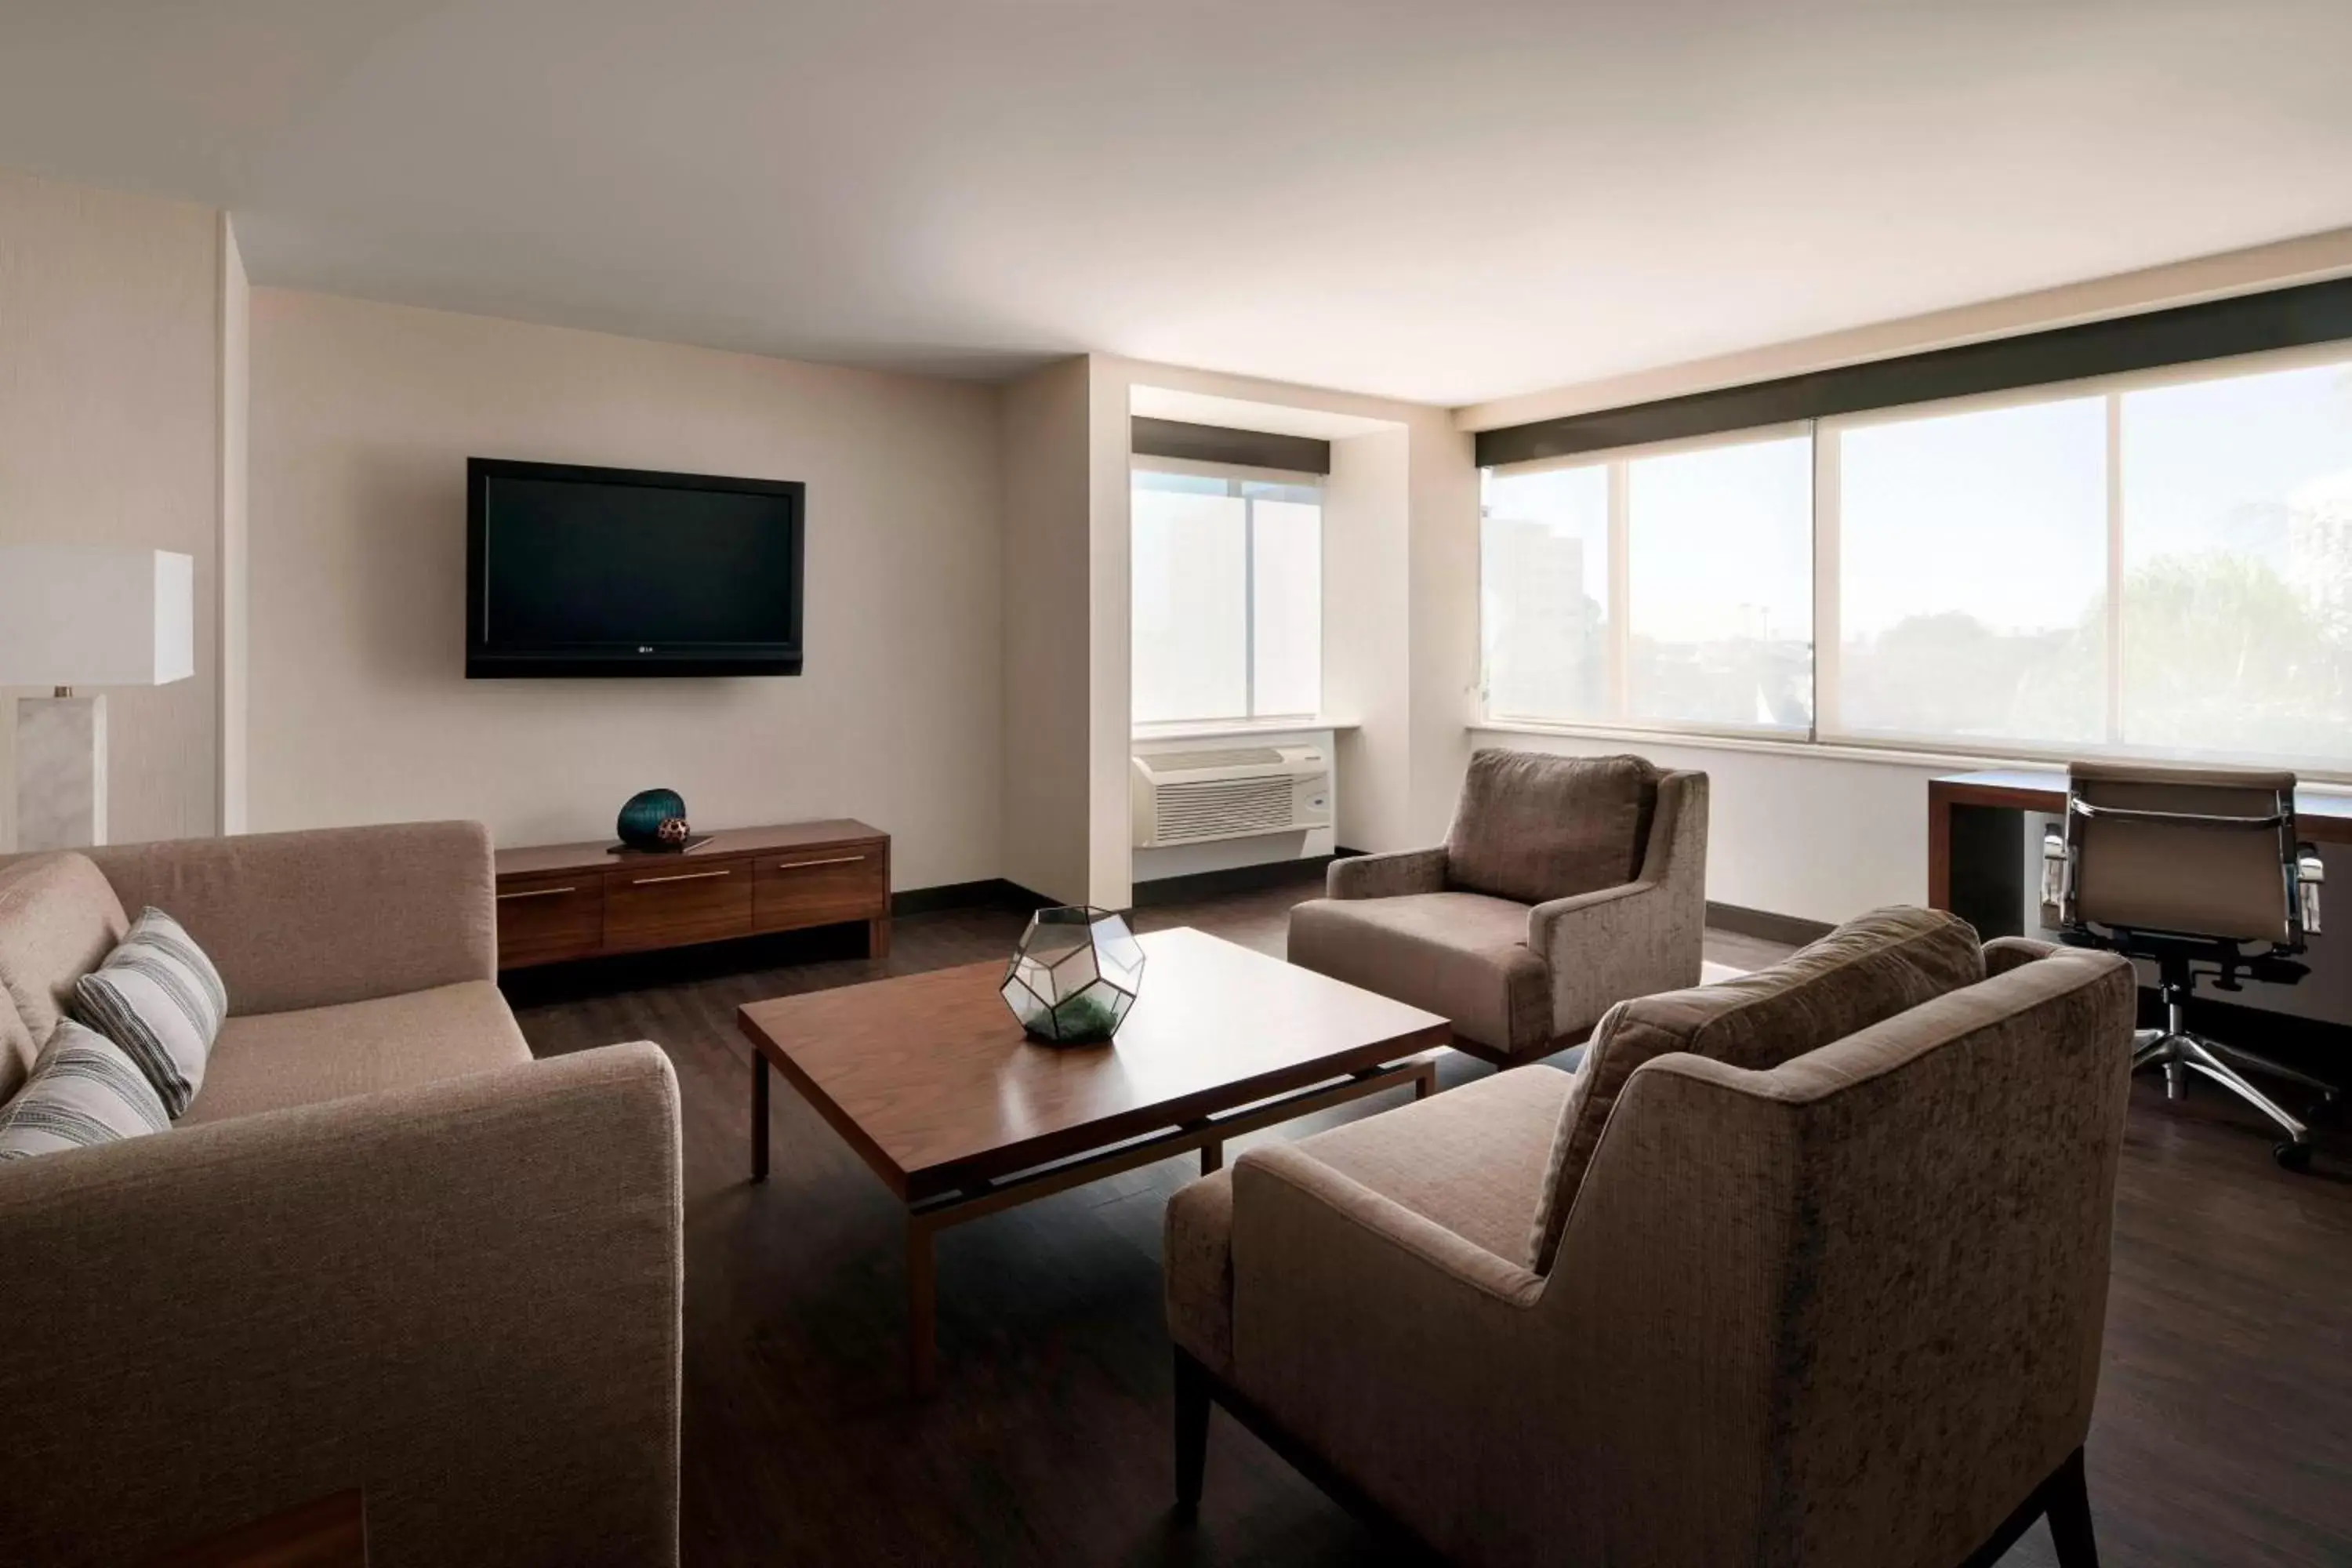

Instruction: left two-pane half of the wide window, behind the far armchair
[1482,435,1813,734]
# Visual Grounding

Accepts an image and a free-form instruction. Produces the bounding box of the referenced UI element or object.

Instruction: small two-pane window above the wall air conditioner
[1129,468,1322,724]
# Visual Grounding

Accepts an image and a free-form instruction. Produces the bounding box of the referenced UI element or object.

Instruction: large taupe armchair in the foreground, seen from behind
[1167,912,2133,1568]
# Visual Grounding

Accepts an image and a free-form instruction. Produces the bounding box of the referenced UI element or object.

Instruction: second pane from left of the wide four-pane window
[1625,435,1813,731]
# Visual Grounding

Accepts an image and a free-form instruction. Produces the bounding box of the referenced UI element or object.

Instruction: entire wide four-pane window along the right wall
[1482,346,2352,776]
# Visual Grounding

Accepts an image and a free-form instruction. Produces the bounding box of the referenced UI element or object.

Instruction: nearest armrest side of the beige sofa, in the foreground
[0,1041,682,1568]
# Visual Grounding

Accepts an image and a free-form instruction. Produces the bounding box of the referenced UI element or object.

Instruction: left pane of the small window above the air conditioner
[1124,475,1249,724]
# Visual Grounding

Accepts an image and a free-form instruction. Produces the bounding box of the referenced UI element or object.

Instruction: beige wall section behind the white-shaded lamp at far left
[0,172,223,846]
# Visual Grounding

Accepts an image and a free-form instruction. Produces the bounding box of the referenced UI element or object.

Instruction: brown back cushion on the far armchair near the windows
[1446,748,1658,902]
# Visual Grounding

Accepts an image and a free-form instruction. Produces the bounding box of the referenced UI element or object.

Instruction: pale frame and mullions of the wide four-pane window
[1475,339,2352,785]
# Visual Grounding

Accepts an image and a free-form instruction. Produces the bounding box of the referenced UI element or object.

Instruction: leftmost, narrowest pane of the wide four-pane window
[1479,463,1611,720]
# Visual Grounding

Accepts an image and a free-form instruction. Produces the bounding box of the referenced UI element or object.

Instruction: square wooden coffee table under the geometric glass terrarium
[736,928,1451,1394]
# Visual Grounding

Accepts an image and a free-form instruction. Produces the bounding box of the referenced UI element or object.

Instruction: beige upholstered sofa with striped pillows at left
[0,822,682,1568]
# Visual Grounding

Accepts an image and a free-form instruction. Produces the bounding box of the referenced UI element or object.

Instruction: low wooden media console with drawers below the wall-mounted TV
[499,820,889,971]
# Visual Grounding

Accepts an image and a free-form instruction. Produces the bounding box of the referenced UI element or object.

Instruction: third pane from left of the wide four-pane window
[1837,397,2107,746]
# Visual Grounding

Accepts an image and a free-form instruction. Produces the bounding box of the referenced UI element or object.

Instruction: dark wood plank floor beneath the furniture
[508,888,2352,1568]
